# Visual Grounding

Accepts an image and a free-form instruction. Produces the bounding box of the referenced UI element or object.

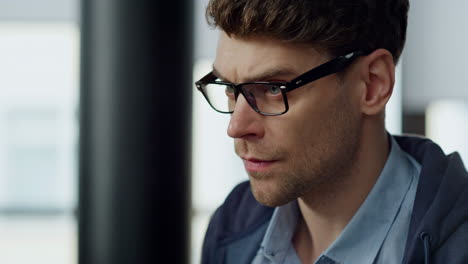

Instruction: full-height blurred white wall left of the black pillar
[0,0,79,264]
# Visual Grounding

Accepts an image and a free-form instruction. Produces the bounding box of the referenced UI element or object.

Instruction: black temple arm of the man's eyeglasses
[286,51,364,92]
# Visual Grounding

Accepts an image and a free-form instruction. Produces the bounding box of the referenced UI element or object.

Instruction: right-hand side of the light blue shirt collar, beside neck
[323,136,414,264]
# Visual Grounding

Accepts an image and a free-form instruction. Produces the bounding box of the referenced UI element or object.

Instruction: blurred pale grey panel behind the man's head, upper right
[403,0,468,113]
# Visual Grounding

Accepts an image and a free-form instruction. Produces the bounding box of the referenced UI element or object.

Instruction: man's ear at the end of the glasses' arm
[360,49,395,115]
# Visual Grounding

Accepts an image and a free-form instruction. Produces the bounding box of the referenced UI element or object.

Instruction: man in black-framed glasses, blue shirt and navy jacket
[196,0,468,264]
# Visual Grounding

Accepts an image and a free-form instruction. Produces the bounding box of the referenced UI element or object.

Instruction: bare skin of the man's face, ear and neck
[213,32,394,263]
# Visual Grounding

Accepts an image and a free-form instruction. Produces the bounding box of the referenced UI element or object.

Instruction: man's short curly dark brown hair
[206,0,409,63]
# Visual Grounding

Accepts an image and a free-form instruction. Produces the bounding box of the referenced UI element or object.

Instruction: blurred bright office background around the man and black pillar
[0,0,468,264]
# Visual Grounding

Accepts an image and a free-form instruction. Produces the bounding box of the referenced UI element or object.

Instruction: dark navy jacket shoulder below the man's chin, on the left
[202,181,274,263]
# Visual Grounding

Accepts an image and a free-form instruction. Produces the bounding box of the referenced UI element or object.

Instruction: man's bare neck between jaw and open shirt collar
[293,122,389,263]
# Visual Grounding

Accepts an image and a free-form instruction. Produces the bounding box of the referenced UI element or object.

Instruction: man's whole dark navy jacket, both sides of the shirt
[202,137,468,264]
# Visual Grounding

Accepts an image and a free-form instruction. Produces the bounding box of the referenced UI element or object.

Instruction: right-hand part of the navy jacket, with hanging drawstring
[395,137,468,263]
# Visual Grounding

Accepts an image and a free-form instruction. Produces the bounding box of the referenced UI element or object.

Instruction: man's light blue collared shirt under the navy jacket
[252,137,421,264]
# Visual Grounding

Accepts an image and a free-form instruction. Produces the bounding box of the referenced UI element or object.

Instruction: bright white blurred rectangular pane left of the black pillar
[0,23,79,211]
